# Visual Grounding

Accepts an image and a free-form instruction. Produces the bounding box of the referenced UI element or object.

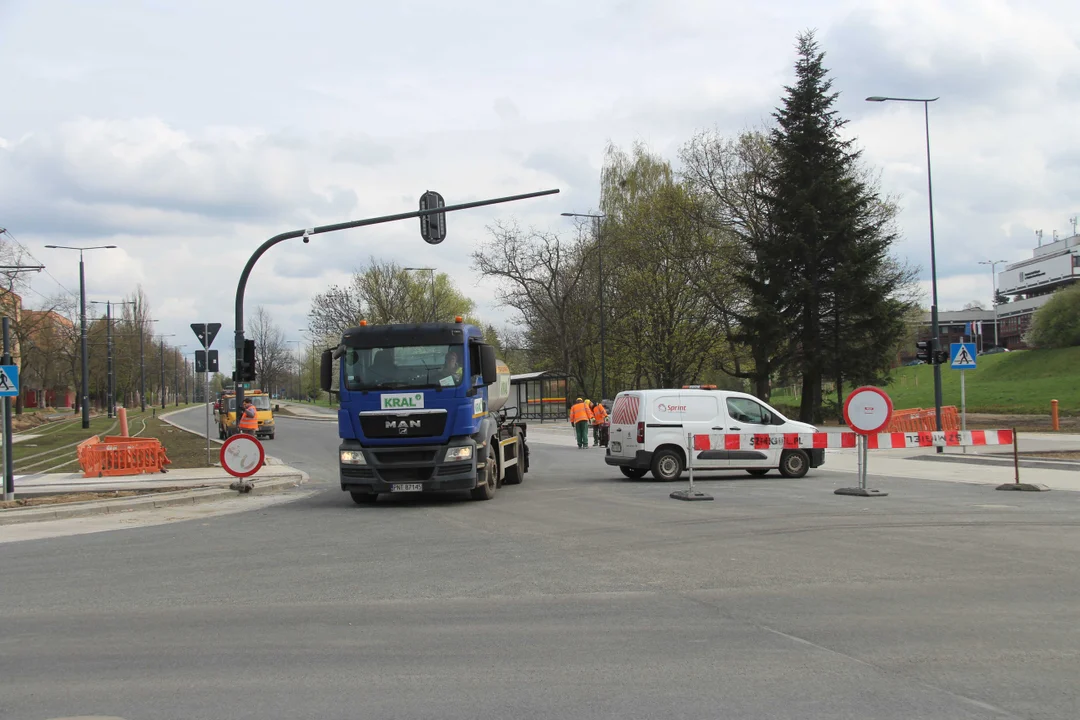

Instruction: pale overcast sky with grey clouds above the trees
[0,0,1080,369]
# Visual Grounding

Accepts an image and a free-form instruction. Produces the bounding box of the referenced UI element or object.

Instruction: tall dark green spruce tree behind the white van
[756,32,910,423]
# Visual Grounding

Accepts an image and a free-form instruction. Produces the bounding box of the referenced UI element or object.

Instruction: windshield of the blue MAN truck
[342,345,464,390]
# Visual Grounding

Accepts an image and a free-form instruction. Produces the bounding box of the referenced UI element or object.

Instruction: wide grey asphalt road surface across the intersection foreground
[0,411,1080,720]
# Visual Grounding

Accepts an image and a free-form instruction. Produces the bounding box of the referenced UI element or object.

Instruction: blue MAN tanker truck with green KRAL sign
[321,317,529,504]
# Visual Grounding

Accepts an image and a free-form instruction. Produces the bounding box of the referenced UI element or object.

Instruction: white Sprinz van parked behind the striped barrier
[604,388,825,481]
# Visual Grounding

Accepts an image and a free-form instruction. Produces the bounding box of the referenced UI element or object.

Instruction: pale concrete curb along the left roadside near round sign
[0,470,310,526]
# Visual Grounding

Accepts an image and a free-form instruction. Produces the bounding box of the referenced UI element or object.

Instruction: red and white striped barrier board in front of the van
[693,430,1013,450]
